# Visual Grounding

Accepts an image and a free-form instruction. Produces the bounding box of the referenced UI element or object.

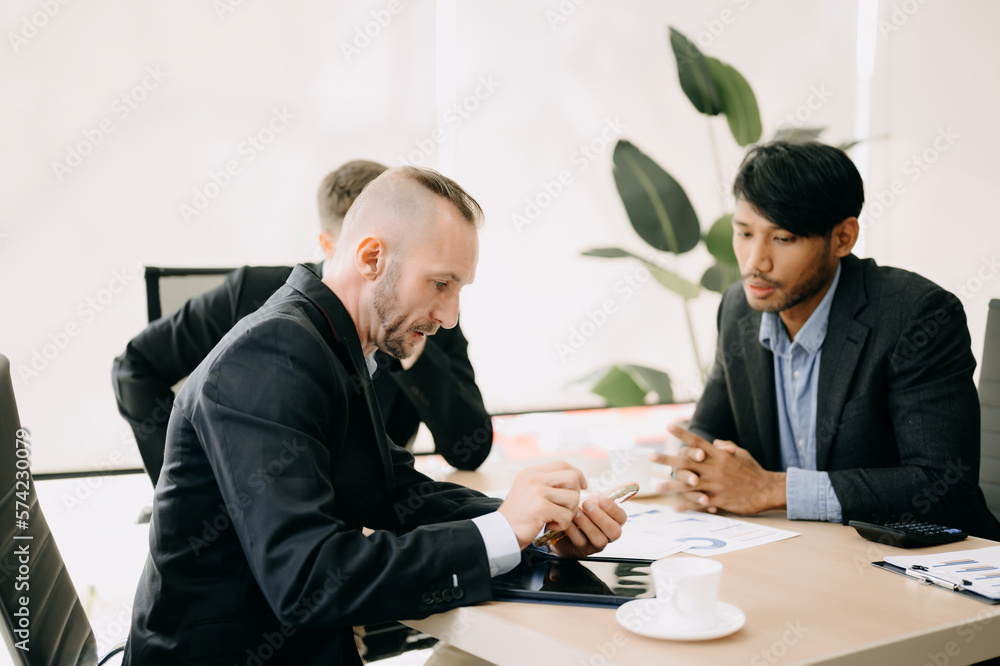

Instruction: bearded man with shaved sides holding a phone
[124,167,625,666]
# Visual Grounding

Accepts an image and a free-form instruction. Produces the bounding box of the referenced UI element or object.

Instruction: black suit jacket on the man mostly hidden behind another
[111,265,493,483]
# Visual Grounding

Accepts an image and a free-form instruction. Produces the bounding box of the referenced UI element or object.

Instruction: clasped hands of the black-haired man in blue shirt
[654,424,785,514]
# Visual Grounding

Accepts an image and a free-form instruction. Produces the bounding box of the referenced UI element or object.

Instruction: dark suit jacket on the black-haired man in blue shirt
[691,255,1000,539]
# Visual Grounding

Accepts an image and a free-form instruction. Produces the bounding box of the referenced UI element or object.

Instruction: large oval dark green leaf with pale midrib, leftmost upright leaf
[614,141,701,254]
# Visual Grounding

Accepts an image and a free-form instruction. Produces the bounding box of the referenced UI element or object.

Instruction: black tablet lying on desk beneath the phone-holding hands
[493,552,656,607]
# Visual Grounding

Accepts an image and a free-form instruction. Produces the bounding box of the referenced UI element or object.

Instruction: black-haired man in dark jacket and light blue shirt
[660,141,1000,539]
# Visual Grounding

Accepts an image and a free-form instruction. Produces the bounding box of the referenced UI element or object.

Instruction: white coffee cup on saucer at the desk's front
[650,556,722,631]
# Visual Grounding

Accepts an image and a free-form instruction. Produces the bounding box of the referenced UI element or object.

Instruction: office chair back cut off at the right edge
[979,298,1000,518]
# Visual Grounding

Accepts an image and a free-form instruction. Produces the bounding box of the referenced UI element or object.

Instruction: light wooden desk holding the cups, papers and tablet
[406,464,1000,666]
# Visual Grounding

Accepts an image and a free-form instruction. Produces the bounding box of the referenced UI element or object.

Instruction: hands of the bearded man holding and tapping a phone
[499,462,626,557]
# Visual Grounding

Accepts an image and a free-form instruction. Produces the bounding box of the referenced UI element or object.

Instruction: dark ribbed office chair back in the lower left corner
[0,355,125,666]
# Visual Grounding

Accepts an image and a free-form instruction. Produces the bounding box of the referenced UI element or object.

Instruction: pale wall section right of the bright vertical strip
[867,1,1000,364]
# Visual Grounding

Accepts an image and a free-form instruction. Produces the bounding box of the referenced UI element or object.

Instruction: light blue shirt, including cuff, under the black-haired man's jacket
[760,265,843,522]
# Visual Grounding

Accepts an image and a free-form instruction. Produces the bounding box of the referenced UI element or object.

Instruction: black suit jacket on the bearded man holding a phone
[124,266,499,666]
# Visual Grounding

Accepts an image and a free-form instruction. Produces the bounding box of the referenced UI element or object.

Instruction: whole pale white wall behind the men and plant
[0,0,1000,471]
